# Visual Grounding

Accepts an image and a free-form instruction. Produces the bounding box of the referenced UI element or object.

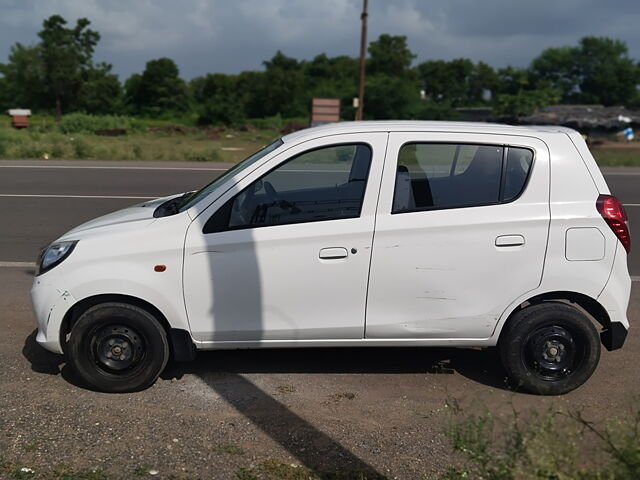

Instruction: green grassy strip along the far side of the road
[0,113,640,167]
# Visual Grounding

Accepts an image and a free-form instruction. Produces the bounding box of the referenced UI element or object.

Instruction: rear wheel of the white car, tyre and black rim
[498,302,600,395]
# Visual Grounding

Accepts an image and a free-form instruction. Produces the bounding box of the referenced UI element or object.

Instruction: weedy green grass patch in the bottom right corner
[440,402,640,480]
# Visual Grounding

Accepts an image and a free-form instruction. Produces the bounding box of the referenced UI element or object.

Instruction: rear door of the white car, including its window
[366,132,550,338]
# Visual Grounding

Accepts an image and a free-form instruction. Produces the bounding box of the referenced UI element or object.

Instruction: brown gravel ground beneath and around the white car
[0,268,640,479]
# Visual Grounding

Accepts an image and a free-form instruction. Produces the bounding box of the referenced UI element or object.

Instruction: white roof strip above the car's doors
[282,120,575,143]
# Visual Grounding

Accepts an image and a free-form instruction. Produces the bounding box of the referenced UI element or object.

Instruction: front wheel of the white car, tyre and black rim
[66,303,169,393]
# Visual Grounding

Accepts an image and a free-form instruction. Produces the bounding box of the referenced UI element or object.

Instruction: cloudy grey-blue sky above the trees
[0,0,640,80]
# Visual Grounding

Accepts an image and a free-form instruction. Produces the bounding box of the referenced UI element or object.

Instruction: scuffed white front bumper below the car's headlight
[31,272,76,353]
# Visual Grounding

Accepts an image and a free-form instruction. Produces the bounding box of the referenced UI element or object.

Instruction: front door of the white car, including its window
[184,133,388,344]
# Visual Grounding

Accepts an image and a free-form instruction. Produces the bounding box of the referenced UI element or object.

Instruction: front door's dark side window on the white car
[204,144,371,233]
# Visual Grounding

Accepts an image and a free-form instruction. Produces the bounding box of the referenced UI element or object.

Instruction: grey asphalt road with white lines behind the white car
[0,161,640,276]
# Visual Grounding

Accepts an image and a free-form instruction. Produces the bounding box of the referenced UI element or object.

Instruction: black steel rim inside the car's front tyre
[92,324,146,373]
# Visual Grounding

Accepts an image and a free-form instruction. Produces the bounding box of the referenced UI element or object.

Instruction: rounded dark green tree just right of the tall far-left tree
[125,57,189,115]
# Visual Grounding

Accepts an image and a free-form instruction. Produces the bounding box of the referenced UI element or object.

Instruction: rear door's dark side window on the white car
[392,143,533,213]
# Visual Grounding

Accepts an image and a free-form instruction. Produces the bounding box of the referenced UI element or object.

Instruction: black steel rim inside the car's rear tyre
[522,324,584,381]
